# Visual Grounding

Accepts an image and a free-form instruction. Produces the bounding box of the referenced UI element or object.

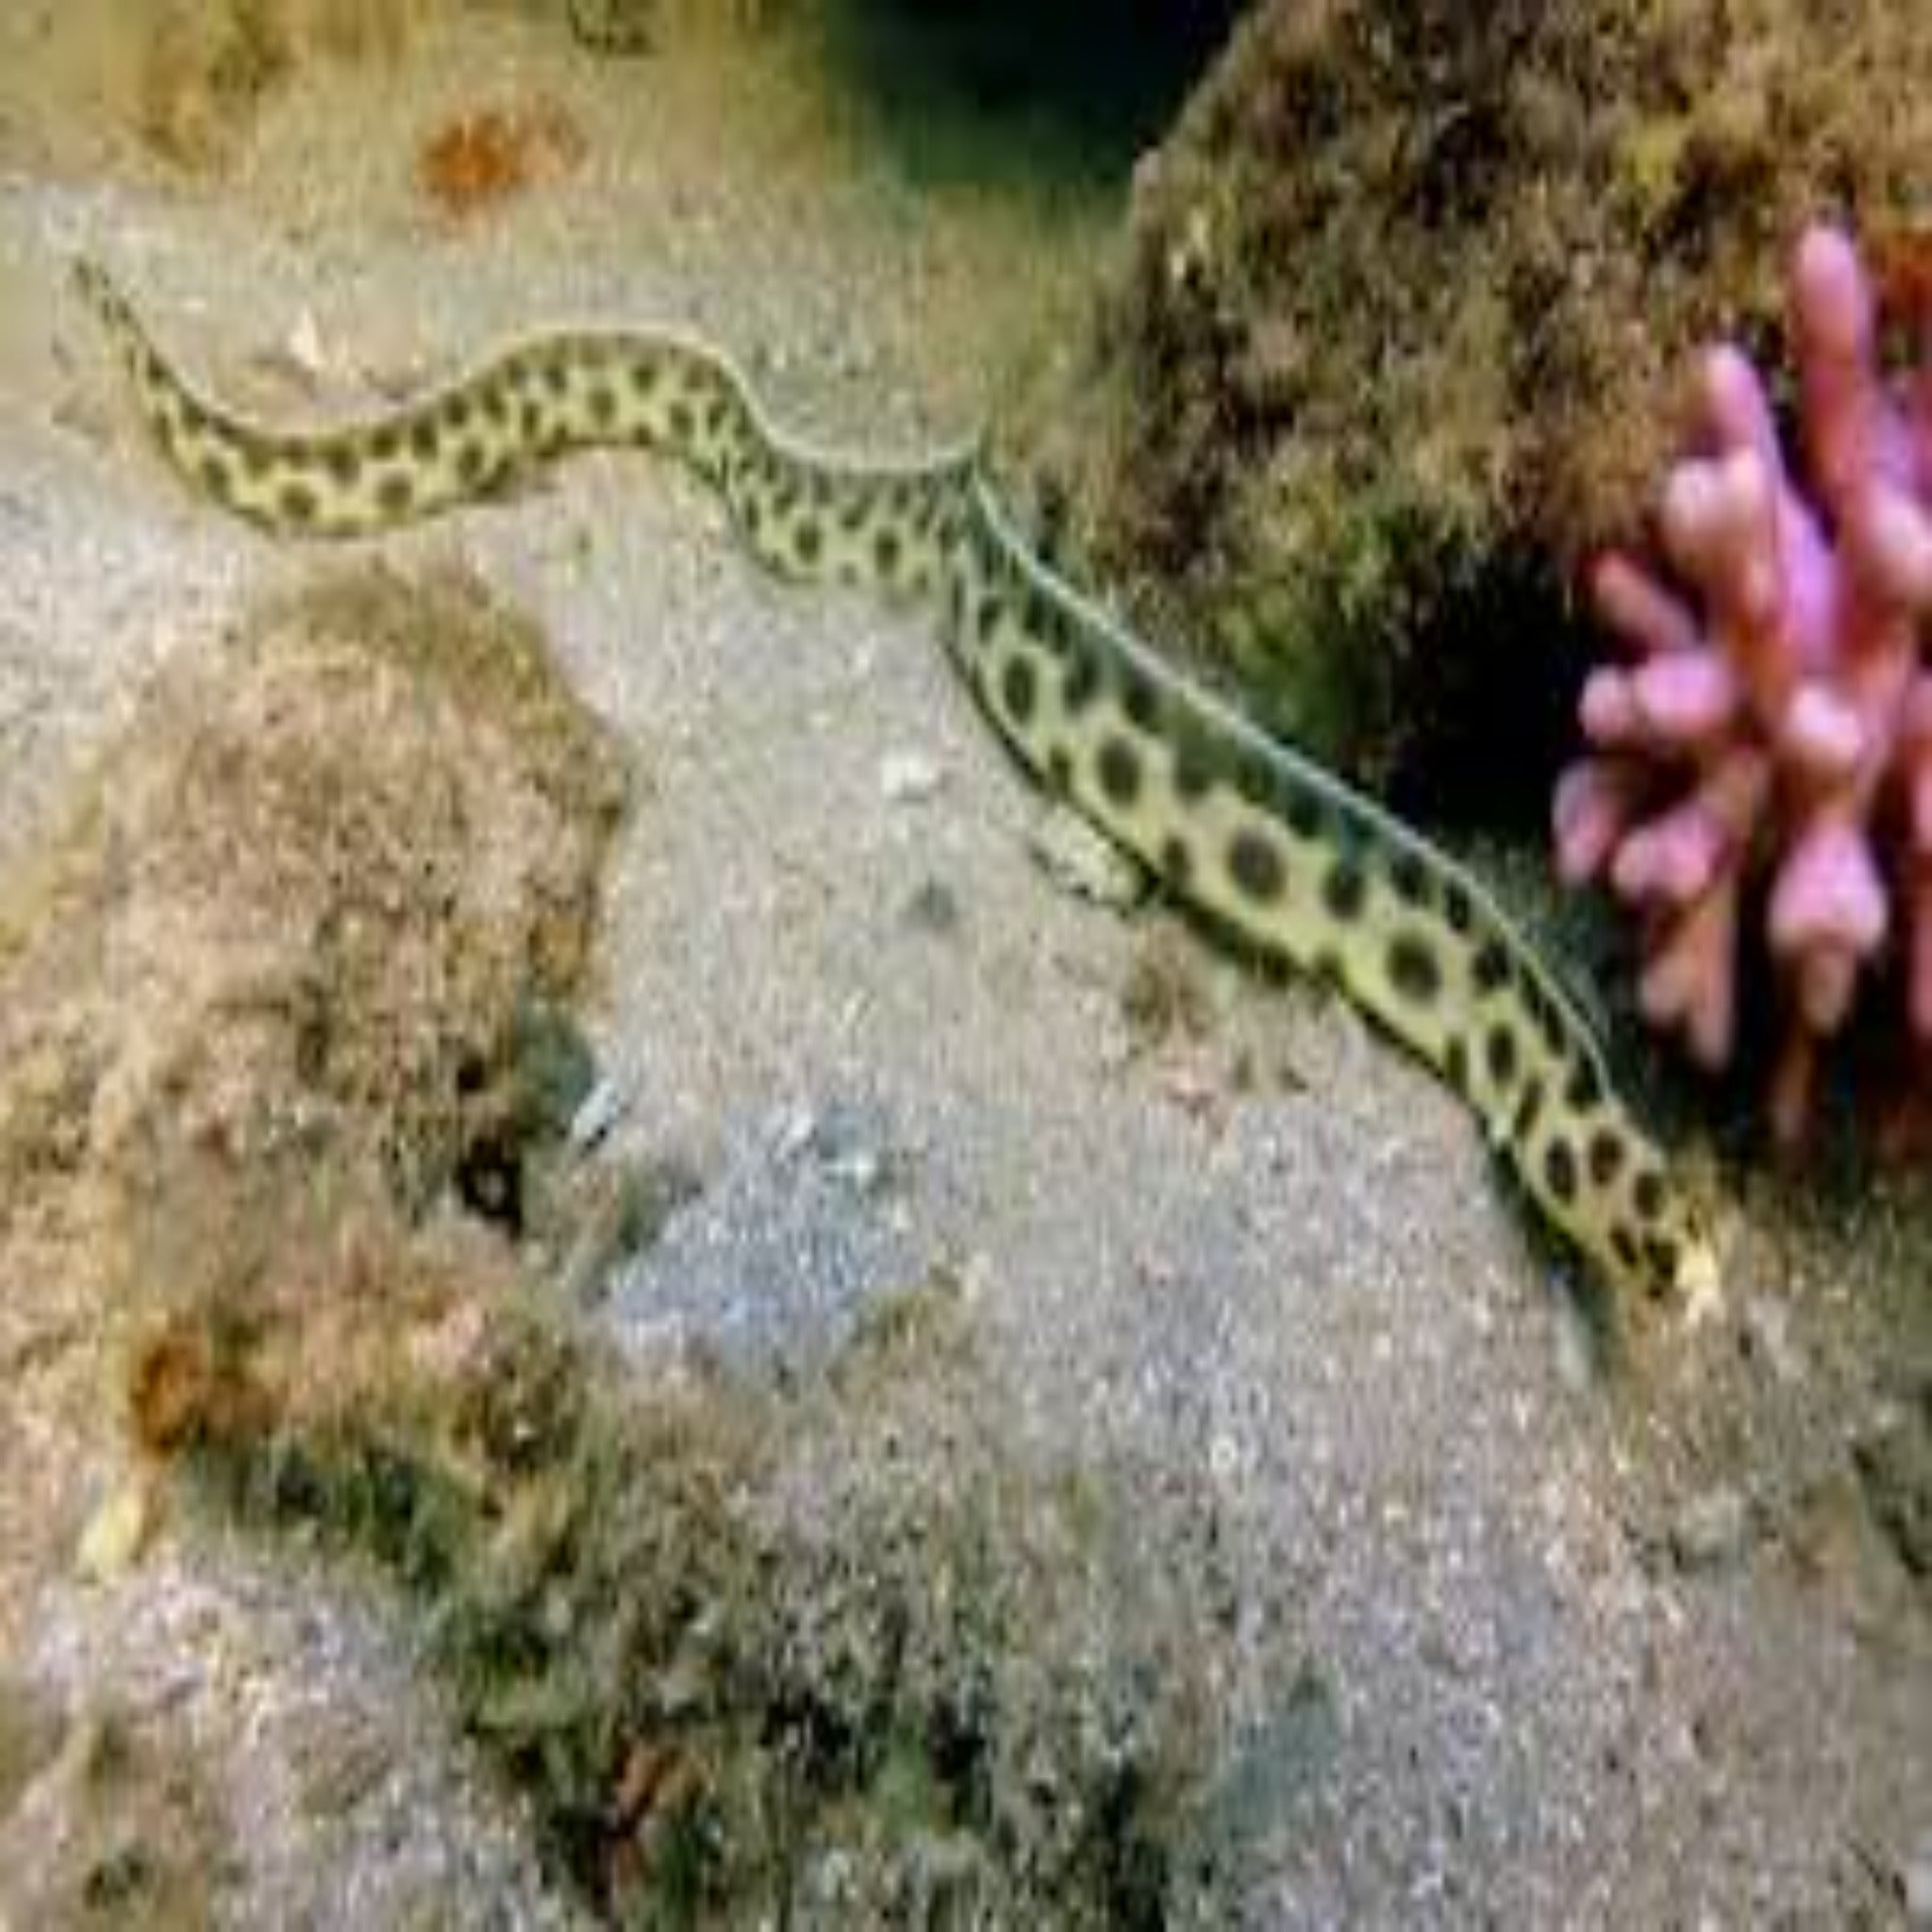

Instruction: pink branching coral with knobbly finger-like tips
[1556,228,1932,1143]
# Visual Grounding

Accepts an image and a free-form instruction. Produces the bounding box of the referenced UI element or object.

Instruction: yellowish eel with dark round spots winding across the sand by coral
[75,260,1718,1298]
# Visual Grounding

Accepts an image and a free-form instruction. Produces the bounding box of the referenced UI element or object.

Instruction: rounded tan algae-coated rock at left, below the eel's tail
[0,572,626,1224]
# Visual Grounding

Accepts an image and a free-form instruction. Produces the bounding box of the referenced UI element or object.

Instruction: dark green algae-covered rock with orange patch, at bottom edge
[135,1252,1211,1926]
